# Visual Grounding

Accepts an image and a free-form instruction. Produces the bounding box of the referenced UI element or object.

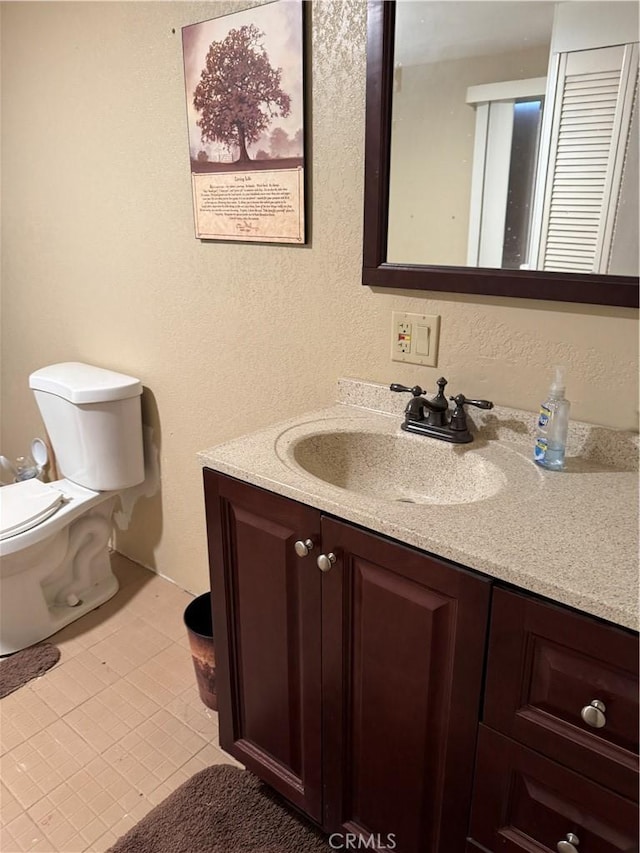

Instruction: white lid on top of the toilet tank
[29,361,142,403]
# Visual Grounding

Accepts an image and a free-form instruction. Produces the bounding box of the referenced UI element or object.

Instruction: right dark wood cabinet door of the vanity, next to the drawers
[322,518,489,853]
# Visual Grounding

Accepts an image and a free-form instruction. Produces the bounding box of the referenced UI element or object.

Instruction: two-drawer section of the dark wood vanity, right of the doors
[469,589,638,853]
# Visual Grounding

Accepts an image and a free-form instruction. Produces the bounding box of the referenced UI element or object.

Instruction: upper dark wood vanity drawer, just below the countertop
[483,589,639,800]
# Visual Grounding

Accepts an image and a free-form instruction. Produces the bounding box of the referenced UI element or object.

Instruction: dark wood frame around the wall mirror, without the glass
[362,0,638,308]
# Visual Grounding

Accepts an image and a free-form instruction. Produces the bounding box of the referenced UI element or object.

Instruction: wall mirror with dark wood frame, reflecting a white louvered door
[362,0,639,307]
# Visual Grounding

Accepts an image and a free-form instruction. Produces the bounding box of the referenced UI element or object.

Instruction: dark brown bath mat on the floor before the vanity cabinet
[107,764,331,853]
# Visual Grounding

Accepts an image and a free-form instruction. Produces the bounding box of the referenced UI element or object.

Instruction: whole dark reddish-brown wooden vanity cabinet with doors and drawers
[204,469,638,853]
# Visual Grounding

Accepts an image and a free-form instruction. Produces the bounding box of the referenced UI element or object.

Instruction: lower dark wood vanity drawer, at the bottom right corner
[470,725,638,853]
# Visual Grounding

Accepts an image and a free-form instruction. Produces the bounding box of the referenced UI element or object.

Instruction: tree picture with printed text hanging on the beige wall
[182,0,305,244]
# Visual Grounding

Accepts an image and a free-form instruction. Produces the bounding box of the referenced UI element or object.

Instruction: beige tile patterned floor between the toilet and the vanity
[0,554,237,853]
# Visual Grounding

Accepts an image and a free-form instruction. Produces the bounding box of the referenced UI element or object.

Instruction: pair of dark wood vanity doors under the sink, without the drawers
[204,470,490,853]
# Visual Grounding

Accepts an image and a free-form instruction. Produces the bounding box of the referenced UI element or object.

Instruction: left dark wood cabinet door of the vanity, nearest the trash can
[204,470,321,821]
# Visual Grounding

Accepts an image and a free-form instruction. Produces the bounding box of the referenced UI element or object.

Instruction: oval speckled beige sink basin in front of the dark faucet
[287,430,507,505]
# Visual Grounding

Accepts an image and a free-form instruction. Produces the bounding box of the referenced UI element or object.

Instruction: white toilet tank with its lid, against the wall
[29,362,144,492]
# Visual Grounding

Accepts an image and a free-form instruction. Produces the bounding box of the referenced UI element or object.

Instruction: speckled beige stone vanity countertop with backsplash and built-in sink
[198,379,639,630]
